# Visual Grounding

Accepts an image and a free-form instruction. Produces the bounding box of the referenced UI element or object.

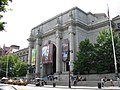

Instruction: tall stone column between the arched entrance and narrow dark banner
[56,18,62,74]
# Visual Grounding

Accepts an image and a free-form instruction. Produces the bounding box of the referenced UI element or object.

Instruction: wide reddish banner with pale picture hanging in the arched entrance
[42,44,53,64]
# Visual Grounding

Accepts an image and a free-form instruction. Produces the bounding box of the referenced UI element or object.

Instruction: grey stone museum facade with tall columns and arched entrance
[28,7,120,80]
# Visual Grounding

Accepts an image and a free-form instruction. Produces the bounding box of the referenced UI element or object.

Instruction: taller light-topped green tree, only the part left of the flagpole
[94,30,114,73]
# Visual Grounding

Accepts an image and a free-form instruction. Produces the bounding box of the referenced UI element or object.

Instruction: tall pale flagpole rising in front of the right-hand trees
[107,5,118,77]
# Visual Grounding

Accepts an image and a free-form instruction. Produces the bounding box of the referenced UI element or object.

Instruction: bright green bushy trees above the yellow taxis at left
[0,54,27,77]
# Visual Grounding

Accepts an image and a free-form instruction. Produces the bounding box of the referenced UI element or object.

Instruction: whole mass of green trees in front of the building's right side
[74,30,120,74]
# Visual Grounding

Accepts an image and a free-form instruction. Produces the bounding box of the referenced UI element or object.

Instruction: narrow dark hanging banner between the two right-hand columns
[62,39,69,61]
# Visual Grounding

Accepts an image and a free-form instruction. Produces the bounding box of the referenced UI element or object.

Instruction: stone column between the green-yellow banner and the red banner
[36,30,42,77]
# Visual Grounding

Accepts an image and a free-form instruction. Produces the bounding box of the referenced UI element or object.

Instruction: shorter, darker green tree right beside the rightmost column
[74,39,94,74]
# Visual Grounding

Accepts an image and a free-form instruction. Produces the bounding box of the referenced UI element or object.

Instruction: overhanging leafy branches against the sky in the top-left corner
[0,0,12,31]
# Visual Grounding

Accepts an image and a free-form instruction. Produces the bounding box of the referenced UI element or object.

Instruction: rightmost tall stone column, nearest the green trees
[68,11,75,72]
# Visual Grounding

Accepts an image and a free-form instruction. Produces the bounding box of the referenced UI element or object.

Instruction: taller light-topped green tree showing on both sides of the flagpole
[95,30,120,73]
